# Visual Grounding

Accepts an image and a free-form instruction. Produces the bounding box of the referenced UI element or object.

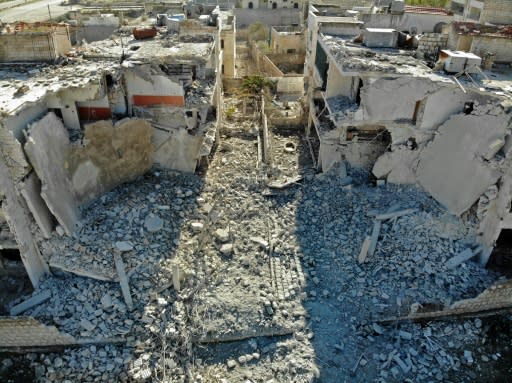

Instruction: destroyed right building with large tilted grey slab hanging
[306,1,512,264]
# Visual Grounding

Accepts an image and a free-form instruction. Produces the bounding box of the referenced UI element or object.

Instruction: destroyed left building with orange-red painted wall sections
[0,17,223,286]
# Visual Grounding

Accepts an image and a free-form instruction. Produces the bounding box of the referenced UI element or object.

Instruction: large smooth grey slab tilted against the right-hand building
[416,114,508,215]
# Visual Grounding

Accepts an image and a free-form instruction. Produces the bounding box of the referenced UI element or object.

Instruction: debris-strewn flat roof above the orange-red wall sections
[0,35,213,115]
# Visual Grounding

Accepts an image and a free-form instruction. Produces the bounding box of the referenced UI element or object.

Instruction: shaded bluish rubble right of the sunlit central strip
[269,148,503,383]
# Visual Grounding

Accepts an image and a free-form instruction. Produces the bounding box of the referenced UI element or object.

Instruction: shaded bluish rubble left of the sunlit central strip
[5,168,207,382]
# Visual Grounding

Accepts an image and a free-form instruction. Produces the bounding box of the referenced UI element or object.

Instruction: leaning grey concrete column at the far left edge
[0,153,49,287]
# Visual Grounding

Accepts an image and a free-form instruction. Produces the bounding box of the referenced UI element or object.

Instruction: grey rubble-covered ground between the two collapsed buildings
[0,112,512,383]
